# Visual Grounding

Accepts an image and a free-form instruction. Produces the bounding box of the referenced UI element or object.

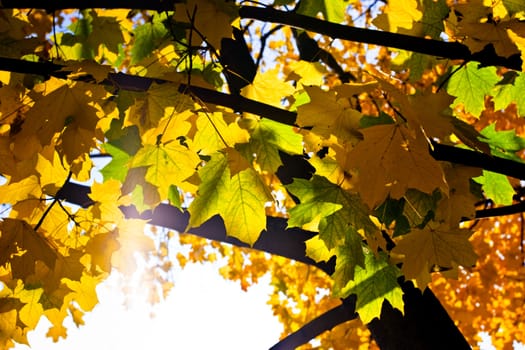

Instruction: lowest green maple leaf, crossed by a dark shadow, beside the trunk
[343,252,404,324]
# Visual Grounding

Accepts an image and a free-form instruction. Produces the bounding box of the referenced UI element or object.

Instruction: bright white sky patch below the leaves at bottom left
[15,264,282,350]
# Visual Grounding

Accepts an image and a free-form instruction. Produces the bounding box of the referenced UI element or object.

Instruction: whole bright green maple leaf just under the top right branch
[447,62,500,117]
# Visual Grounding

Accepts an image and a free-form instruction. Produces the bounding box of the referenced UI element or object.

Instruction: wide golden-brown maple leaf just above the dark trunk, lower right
[392,224,477,288]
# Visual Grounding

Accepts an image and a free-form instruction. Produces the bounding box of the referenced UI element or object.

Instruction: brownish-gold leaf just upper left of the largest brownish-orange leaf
[297,86,361,141]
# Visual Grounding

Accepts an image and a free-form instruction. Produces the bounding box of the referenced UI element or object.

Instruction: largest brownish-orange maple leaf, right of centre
[348,124,446,208]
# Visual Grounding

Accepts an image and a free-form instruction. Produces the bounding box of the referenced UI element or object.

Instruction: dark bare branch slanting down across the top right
[239,6,521,71]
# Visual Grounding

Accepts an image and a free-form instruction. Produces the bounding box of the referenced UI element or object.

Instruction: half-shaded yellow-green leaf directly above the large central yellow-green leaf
[236,118,303,172]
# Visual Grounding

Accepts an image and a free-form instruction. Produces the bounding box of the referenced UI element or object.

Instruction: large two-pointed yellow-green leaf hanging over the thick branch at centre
[188,152,272,245]
